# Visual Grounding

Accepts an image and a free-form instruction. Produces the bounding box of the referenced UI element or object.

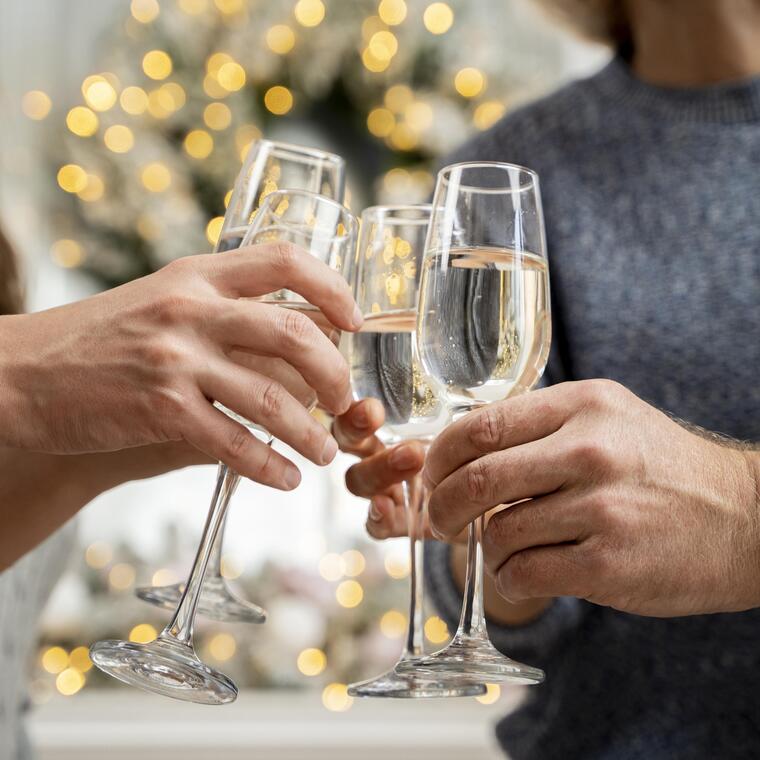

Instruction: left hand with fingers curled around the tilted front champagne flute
[0,243,362,489]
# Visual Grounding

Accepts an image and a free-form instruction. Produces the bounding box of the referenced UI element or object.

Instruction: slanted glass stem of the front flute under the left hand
[161,462,240,645]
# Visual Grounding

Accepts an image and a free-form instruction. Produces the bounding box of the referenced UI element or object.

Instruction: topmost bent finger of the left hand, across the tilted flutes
[208,242,364,331]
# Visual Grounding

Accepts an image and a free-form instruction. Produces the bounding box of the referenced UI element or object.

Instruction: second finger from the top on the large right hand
[428,437,567,540]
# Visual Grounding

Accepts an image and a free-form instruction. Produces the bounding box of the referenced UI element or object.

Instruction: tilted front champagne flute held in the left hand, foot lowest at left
[90,191,357,704]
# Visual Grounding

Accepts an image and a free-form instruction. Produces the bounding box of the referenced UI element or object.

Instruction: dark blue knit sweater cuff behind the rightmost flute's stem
[425,541,588,665]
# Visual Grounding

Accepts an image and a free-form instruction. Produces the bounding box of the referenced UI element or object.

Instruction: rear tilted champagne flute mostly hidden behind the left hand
[135,140,345,623]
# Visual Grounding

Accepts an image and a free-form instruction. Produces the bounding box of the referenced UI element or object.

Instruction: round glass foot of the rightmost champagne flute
[397,636,545,685]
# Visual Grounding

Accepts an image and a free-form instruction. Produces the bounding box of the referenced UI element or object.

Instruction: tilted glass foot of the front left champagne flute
[90,639,238,705]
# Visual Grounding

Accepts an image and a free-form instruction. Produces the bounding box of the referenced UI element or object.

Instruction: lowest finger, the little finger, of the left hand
[185,399,301,491]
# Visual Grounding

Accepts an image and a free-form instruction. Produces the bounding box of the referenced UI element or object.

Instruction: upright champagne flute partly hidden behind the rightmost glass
[342,206,486,698]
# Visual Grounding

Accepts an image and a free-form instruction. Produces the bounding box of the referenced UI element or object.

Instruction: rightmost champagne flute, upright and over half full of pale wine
[406,162,551,684]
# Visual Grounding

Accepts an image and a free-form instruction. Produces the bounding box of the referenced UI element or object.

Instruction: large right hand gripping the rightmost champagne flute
[424,380,760,616]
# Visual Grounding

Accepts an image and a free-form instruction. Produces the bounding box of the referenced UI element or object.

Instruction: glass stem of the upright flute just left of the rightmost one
[401,475,428,660]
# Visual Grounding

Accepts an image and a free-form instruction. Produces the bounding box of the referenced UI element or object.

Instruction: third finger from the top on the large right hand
[483,491,590,575]
